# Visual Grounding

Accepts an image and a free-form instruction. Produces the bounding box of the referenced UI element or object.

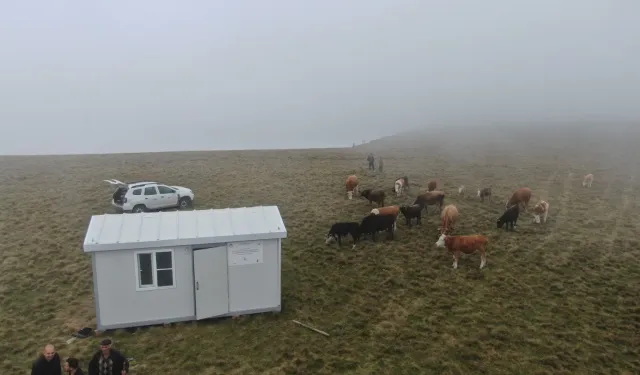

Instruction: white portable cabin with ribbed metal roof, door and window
[84,206,287,330]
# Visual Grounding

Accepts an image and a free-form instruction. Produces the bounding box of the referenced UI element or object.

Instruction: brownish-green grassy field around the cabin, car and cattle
[0,130,640,374]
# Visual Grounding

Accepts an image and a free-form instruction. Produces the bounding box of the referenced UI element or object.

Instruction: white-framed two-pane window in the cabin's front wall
[136,250,175,290]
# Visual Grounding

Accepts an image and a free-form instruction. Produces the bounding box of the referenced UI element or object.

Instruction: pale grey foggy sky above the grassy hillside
[0,0,640,154]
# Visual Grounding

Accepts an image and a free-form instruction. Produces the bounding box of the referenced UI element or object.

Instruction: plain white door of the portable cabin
[193,246,229,319]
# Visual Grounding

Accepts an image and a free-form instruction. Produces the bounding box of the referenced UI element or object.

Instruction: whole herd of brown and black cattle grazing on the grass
[325,170,593,269]
